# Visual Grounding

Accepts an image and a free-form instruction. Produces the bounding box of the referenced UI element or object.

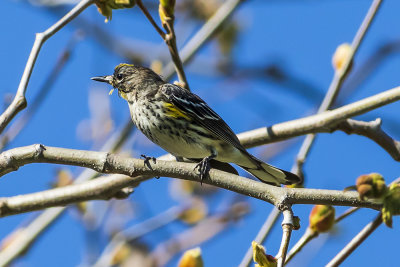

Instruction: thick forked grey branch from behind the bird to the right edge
[238,87,400,161]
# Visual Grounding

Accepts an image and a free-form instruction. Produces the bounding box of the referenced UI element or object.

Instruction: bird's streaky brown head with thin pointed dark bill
[91,63,164,102]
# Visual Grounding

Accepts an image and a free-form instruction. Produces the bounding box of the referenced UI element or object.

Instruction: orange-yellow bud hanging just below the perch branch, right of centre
[309,205,335,233]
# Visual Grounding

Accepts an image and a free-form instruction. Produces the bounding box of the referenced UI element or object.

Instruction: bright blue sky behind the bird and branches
[0,0,400,266]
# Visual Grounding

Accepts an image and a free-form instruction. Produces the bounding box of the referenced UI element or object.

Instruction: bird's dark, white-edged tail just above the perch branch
[240,154,301,186]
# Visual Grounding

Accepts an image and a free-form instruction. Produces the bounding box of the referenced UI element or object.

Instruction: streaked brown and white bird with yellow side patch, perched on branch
[92,64,300,185]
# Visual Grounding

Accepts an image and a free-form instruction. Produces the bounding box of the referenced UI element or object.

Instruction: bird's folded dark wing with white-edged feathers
[160,83,245,151]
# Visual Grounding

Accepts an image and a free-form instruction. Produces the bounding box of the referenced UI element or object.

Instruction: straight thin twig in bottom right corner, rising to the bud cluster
[326,212,382,267]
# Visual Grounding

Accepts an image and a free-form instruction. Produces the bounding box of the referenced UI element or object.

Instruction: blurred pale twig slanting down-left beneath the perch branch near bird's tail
[239,207,281,267]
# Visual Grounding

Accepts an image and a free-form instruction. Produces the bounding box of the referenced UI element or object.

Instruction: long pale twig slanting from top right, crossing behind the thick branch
[292,0,382,178]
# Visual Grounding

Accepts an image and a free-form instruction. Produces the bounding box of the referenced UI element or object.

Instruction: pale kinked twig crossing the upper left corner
[0,0,94,133]
